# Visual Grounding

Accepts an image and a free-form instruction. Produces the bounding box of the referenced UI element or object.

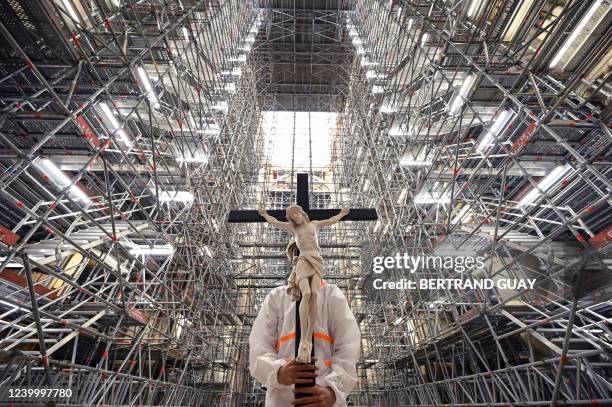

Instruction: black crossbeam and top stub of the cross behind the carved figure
[227,173,378,223]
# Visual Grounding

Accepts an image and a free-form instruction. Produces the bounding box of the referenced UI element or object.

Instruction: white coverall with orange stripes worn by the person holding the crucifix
[249,281,361,407]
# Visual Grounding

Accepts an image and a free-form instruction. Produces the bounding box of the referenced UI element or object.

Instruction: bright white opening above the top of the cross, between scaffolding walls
[262,111,337,169]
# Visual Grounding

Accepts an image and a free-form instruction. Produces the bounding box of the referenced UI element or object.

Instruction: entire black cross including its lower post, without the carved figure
[227,173,378,398]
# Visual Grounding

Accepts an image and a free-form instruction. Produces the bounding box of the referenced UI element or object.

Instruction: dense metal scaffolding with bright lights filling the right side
[341,0,612,406]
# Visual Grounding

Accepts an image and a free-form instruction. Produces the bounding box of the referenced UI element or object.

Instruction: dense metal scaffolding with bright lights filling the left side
[0,0,260,406]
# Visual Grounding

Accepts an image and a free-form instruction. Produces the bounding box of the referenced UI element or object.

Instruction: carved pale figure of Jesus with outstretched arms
[257,205,349,363]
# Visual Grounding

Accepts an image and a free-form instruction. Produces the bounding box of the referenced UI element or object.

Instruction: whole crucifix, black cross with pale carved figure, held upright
[228,173,378,398]
